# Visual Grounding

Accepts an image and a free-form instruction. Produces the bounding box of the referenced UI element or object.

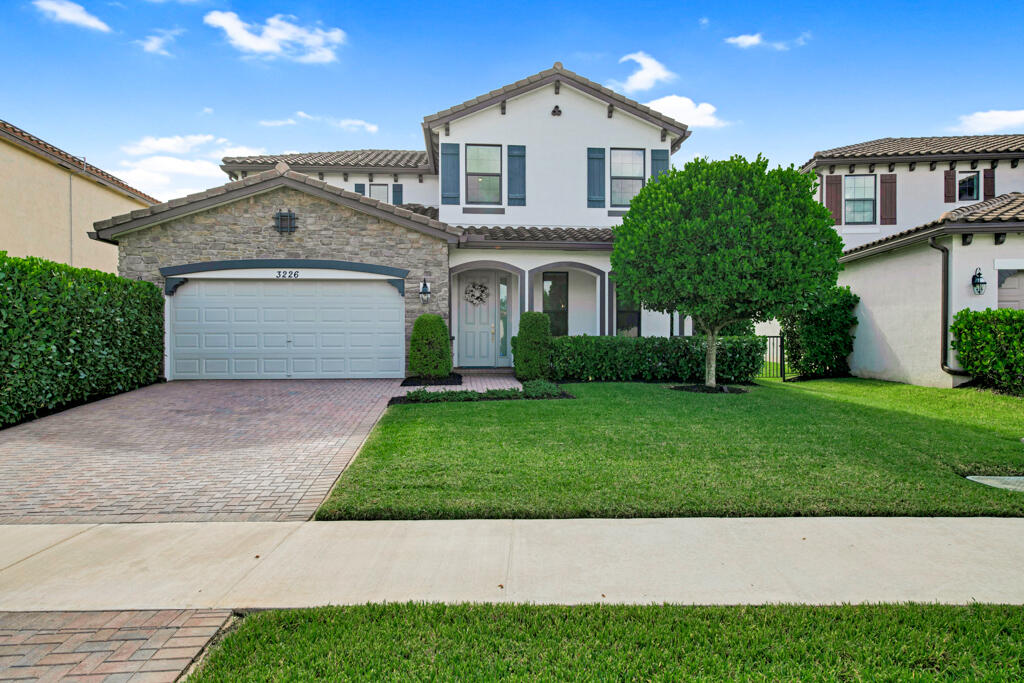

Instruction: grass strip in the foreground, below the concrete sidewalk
[188,604,1024,683]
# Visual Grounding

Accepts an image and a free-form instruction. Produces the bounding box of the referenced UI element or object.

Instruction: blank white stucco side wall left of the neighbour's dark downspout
[839,244,953,388]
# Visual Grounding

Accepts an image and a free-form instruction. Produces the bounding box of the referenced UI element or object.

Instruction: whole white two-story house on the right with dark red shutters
[804,134,1024,387]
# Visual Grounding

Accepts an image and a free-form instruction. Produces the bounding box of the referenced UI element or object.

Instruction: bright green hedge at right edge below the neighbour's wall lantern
[949,308,1024,396]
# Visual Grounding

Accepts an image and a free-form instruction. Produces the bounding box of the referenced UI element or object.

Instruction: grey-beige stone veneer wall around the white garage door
[118,187,451,355]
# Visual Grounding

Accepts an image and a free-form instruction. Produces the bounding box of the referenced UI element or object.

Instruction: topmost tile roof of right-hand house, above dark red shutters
[805,134,1024,167]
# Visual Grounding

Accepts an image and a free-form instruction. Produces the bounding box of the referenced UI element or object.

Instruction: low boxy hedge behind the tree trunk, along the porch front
[551,336,765,384]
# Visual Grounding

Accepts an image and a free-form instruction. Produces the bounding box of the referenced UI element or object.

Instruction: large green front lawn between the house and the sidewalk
[317,379,1024,519]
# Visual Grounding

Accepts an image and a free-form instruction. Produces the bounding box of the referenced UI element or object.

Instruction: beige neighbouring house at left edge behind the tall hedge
[0,121,157,272]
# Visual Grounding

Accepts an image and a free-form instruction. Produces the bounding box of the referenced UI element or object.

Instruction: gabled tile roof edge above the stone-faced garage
[93,162,462,239]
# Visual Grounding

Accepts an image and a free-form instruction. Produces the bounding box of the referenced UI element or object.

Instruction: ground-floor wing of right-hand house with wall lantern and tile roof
[839,193,1024,387]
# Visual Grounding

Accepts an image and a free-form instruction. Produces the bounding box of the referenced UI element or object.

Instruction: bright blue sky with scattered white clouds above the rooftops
[6,0,1024,200]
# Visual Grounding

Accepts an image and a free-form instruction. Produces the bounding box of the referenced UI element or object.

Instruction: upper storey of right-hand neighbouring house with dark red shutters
[803,134,1024,249]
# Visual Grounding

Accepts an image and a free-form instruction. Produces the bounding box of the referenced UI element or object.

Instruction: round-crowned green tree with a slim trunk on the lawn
[611,155,843,387]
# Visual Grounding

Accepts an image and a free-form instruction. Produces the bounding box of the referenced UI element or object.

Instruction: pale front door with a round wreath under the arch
[456,270,498,368]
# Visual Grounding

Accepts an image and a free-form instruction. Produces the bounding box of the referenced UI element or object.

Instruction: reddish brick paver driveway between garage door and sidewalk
[0,380,401,523]
